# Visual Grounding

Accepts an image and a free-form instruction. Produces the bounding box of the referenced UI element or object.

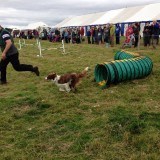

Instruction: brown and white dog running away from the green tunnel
[45,67,88,92]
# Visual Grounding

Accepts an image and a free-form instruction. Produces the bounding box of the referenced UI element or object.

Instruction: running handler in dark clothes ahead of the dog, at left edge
[0,25,39,84]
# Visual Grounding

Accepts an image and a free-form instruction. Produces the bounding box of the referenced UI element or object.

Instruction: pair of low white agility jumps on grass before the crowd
[18,39,66,57]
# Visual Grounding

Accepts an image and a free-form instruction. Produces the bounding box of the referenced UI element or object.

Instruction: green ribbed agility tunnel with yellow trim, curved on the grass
[94,51,153,88]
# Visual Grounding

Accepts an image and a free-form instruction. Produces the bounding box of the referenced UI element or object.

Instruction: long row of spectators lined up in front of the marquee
[10,21,160,48]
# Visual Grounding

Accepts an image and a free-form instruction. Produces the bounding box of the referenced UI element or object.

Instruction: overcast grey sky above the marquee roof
[0,0,160,27]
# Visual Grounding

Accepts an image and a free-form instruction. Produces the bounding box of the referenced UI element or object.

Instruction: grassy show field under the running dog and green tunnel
[0,40,160,160]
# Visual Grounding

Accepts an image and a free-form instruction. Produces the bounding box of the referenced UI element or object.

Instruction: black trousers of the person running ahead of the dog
[0,53,34,82]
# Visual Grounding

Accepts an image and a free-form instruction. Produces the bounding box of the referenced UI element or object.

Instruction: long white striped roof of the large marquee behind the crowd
[54,3,160,28]
